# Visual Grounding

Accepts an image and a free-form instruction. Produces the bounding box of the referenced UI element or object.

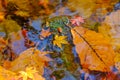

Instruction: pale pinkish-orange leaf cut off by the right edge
[102,10,120,49]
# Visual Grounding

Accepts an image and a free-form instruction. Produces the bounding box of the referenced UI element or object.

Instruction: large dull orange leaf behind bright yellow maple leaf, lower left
[10,48,51,74]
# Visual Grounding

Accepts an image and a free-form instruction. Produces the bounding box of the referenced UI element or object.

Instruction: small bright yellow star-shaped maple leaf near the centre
[53,35,68,48]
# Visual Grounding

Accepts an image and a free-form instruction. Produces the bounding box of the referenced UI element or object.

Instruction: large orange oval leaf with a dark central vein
[71,27,115,72]
